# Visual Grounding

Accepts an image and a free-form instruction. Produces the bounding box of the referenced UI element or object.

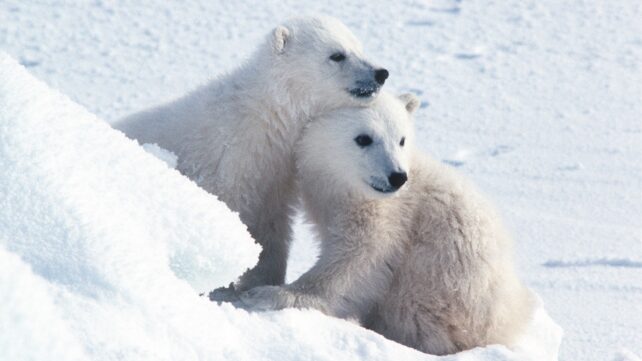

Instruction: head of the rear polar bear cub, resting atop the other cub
[268,16,388,109]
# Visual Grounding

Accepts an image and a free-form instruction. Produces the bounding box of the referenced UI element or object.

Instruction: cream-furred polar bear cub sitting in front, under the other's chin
[241,93,534,355]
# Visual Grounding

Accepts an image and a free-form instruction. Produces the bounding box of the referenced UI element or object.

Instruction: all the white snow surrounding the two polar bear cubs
[0,0,642,361]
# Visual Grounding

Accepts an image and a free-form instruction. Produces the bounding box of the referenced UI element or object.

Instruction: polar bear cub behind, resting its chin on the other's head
[116,17,388,298]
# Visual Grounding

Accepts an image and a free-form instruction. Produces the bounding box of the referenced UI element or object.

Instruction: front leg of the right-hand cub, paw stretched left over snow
[240,206,399,321]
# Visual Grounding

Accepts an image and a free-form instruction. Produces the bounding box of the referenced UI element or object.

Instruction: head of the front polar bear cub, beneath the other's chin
[297,92,419,198]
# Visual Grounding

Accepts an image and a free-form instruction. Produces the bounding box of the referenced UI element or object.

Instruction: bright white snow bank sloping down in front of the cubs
[0,54,561,361]
